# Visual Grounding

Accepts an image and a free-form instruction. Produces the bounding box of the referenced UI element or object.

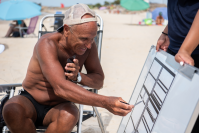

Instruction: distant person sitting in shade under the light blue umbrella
[5,20,27,37]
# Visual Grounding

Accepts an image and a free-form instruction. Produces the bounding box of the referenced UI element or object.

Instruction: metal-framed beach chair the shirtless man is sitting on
[0,14,105,133]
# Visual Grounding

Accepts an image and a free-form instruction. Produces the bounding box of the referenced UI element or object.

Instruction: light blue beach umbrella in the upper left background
[0,0,41,20]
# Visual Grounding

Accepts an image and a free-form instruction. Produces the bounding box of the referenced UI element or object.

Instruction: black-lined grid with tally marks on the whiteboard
[124,58,175,133]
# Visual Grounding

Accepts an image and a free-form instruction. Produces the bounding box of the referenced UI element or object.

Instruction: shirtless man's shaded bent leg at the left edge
[3,95,37,133]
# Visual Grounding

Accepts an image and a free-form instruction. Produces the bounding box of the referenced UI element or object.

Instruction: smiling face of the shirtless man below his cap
[67,22,97,55]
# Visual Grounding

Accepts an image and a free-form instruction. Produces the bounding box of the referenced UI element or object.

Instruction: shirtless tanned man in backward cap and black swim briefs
[3,4,133,133]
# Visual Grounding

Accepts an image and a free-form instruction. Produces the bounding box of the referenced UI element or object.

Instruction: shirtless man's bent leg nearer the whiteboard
[43,102,79,133]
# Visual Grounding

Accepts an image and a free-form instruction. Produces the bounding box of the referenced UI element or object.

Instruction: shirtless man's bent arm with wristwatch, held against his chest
[65,43,104,89]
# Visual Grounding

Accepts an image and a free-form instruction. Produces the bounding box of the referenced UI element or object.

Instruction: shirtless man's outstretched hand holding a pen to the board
[103,97,134,116]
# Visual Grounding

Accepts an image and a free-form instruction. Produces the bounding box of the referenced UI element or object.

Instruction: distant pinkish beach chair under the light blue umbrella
[15,16,39,37]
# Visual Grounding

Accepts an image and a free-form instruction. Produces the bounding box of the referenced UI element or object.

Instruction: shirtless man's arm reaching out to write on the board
[35,38,133,116]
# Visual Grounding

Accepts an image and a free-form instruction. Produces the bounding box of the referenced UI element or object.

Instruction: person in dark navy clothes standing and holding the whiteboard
[156,0,199,133]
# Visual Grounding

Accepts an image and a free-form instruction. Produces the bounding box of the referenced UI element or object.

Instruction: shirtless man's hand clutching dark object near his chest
[65,59,80,81]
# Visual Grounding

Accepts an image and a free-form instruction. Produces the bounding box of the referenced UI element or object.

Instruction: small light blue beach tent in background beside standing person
[152,7,168,20]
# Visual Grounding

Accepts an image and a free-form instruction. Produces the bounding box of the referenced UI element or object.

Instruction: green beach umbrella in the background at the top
[120,0,149,11]
